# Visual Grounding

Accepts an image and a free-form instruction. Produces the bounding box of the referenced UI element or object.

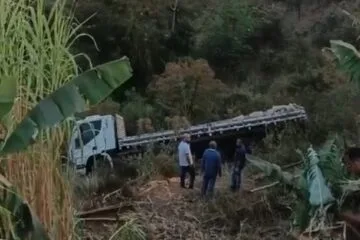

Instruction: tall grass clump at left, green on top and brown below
[0,0,93,239]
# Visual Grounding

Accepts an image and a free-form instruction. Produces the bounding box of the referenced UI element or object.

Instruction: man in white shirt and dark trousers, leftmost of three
[178,134,195,189]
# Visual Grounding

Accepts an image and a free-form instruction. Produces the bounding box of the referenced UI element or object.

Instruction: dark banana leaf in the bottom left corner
[0,175,50,240]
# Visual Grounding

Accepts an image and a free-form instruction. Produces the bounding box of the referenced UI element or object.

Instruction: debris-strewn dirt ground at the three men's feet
[79,170,293,240]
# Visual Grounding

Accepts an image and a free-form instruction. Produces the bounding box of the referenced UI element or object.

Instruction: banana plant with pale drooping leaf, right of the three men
[247,139,344,230]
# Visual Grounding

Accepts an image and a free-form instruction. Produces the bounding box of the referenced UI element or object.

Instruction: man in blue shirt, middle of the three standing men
[201,141,221,196]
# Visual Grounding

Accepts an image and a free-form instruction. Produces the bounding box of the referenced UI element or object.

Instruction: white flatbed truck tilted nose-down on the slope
[68,104,307,173]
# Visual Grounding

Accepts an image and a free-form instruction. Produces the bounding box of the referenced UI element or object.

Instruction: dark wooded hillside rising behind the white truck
[76,0,358,143]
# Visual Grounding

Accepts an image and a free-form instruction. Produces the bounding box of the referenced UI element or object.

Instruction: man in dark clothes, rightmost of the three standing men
[230,139,251,191]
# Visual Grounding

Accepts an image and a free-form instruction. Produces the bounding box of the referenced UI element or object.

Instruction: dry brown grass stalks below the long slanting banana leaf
[6,127,74,239]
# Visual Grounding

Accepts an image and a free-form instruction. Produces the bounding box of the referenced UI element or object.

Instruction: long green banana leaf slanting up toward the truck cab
[0,57,132,154]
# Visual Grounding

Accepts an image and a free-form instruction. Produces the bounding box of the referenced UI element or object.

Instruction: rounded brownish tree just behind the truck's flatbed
[148,58,226,120]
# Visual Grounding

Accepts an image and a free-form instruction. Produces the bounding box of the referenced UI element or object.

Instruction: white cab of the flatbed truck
[68,115,125,173]
